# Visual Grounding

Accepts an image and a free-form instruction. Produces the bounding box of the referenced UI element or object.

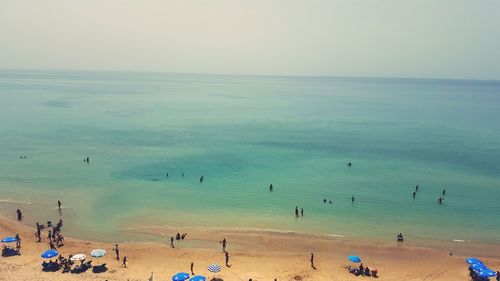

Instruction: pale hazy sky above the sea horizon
[0,0,500,80]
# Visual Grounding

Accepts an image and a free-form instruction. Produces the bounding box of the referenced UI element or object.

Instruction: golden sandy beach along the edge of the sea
[0,215,500,281]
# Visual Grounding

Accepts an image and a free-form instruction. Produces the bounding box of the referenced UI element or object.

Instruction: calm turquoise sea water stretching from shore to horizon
[0,71,500,243]
